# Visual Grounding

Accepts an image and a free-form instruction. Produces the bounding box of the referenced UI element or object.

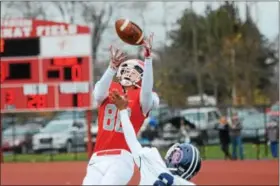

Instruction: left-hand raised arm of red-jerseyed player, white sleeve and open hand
[93,46,126,105]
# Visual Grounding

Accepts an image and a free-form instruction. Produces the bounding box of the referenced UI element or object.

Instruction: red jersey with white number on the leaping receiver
[94,82,146,152]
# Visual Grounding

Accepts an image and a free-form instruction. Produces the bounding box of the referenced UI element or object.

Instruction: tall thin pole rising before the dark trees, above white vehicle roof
[190,1,204,105]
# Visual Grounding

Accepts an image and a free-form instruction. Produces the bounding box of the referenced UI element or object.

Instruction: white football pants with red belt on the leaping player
[83,150,140,185]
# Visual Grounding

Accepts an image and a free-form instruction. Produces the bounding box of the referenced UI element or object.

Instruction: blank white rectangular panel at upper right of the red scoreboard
[40,34,91,57]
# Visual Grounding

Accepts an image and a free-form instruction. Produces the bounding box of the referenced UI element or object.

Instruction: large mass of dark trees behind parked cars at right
[156,2,277,104]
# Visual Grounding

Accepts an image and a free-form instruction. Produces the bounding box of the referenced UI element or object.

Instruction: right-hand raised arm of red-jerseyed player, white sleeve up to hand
[140,34,159,115]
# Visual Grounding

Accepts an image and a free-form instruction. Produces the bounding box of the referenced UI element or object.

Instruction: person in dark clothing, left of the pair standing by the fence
[218,117,232,160]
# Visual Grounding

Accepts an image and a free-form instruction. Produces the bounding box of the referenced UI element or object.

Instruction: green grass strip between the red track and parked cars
[4,144,272,162]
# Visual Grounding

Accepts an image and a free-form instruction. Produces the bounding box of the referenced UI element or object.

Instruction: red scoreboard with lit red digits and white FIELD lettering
[0,19,93,113]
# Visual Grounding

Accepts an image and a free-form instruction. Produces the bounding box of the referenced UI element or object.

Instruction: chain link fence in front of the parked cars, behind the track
[1,106,279,162]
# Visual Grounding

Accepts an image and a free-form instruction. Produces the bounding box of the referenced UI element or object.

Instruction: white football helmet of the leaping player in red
[116,59,144,87]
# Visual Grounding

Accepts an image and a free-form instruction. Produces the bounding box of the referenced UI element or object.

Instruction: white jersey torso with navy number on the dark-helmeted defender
[135,147,195,186]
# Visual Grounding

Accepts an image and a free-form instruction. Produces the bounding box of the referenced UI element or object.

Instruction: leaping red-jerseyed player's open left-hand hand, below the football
[110,45,127,70]
